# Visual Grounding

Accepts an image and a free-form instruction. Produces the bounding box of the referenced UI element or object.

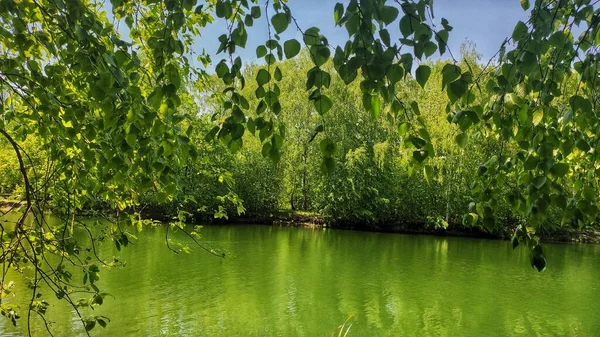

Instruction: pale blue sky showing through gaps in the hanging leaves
[197,0,528,64]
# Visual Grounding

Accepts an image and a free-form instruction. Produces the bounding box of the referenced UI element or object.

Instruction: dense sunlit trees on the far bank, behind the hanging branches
[0,44,573,231]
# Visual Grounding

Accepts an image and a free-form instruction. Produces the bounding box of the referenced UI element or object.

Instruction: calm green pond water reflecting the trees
[0,226,600,337]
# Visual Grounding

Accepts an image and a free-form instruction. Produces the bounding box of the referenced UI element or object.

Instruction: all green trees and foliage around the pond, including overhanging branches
[0,0,600,336]
